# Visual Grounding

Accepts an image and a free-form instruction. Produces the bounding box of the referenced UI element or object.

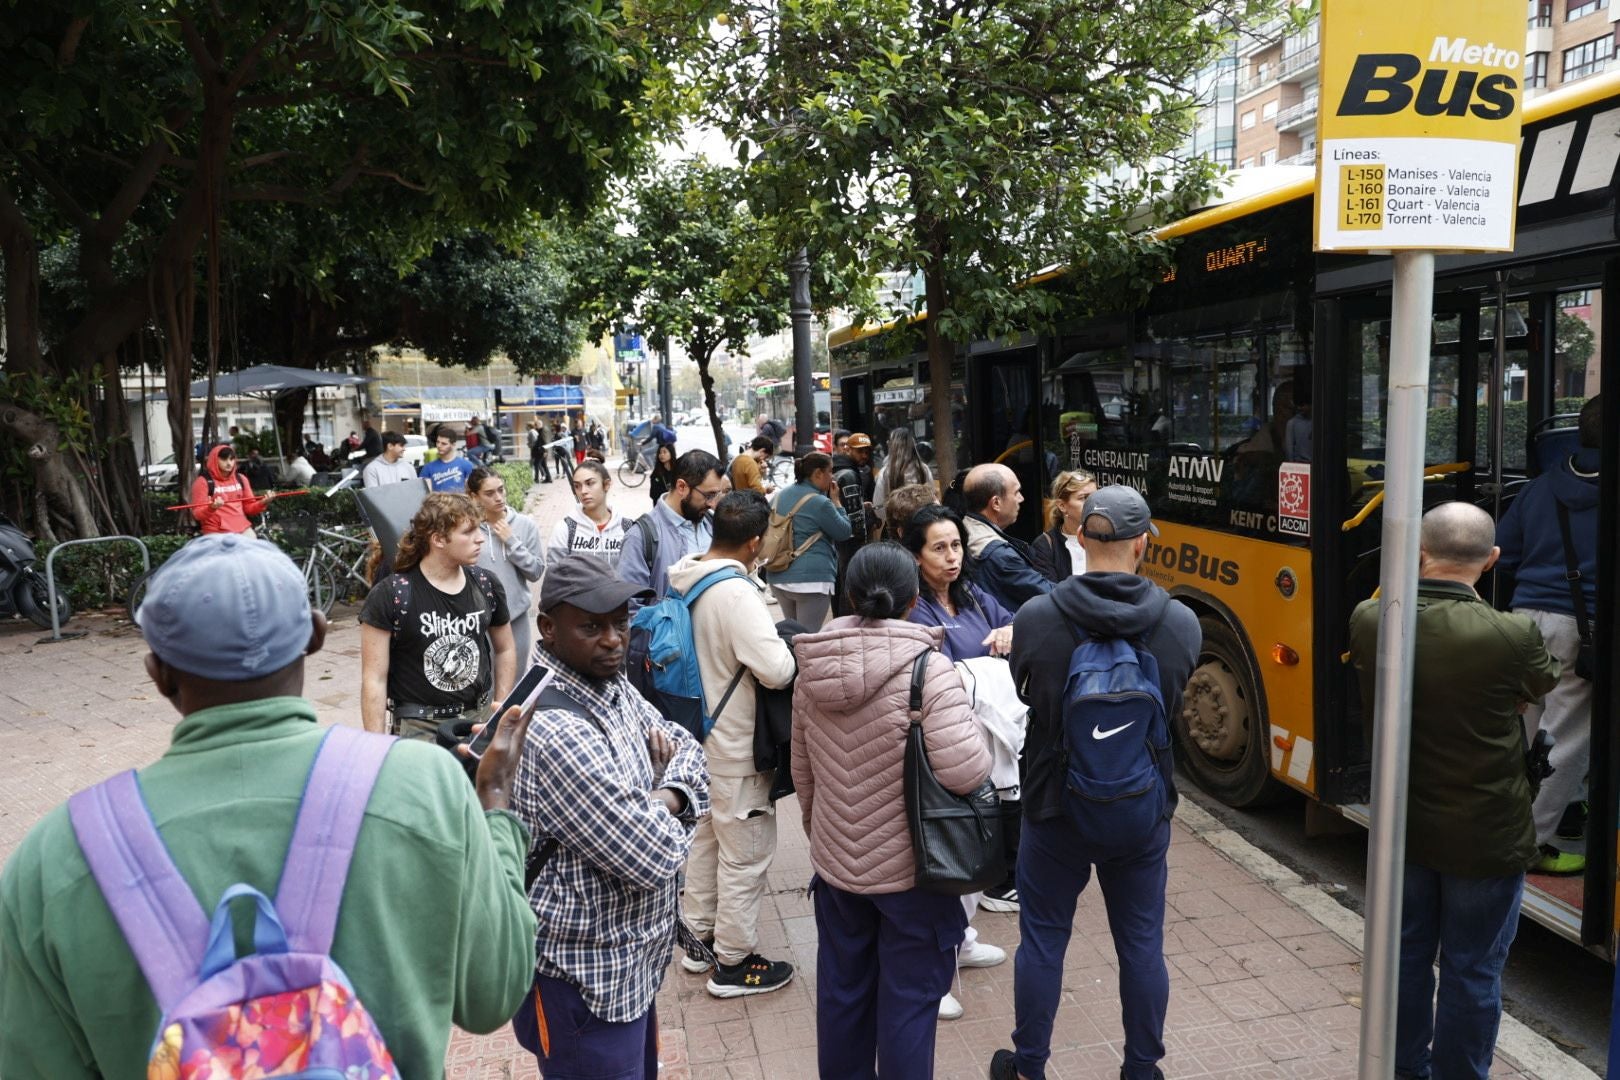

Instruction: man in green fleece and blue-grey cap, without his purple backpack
[0,533,535,1080]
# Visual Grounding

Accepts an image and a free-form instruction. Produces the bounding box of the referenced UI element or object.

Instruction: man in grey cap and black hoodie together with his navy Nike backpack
[990,486,1202,1080]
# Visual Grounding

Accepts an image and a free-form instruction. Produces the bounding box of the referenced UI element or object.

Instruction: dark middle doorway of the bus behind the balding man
[965,348,1056,541]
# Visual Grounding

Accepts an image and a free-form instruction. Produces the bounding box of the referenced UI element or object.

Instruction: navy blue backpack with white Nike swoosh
[1061,597,1170,850]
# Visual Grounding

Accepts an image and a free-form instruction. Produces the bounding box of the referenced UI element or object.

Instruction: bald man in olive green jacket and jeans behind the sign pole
[1349,502,1558,1080]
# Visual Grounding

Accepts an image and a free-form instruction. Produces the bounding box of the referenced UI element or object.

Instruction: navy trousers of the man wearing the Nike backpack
[1013,818,1170,1080]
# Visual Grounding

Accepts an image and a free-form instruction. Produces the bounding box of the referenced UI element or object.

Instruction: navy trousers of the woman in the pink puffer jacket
[810,878,967,1080]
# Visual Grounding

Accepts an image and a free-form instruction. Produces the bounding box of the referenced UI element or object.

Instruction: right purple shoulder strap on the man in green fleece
[275,727,394,955]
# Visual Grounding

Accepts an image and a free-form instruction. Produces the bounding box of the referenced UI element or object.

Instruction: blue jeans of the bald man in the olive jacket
[1395,863,1524,1080]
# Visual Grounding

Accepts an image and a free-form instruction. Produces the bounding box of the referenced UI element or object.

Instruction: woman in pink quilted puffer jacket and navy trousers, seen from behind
[792,542,990,1080]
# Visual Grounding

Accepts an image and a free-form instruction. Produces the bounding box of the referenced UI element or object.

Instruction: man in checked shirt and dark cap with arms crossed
[512,559,710,1080]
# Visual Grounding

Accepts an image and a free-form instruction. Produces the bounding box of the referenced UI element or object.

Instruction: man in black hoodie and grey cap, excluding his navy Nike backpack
[990,486,1202,1080]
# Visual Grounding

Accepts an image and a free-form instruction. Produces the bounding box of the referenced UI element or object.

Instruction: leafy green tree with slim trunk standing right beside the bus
[682,0,1277,471]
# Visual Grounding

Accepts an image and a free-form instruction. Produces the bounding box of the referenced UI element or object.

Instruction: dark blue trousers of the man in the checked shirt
[512,975,658,1080]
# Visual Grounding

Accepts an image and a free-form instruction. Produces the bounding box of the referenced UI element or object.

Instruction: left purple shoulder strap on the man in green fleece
[68,771,209,1014]
